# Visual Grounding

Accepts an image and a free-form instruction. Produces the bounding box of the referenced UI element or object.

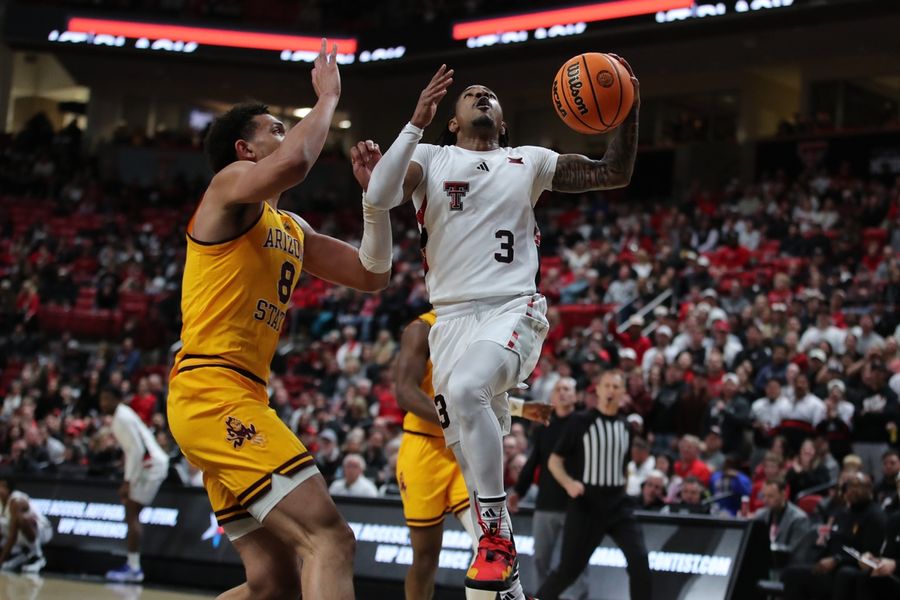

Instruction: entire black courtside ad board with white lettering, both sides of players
[19,479,768,600]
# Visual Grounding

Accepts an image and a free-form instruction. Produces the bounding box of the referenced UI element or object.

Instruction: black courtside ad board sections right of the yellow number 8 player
[338,499,768,600]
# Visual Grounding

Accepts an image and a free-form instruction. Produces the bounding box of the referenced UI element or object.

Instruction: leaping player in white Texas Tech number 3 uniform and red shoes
[353,57,640,597]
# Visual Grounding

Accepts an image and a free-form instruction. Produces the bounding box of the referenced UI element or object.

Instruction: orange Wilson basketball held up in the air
[552,52,634,134]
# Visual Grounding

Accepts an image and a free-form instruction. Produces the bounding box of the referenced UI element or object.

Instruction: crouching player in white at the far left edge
[0,477,53,573]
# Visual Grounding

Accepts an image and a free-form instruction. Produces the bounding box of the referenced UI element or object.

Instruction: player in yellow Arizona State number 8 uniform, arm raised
[168,40,391,600]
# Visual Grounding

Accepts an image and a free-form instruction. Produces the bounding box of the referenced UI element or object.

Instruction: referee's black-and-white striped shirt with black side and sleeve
[554,410,631,487]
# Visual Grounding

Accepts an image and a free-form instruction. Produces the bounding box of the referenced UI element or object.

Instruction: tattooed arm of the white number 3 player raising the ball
[553,57,641,192]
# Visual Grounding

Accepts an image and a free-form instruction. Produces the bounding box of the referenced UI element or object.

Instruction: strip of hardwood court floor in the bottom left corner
[0,573,214,600]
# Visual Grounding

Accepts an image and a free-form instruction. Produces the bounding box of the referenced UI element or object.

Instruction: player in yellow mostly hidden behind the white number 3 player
[395,311,552,600]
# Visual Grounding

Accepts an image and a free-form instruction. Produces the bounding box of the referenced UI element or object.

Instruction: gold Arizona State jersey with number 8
[175,203,303,384]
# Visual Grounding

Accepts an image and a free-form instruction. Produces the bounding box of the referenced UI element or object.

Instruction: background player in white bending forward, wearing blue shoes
[100,388,169,583]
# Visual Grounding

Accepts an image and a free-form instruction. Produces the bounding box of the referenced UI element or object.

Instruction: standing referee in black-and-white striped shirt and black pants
[537,370,650,600]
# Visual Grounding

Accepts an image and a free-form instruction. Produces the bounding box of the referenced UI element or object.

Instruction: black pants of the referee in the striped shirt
[537,487,650,600]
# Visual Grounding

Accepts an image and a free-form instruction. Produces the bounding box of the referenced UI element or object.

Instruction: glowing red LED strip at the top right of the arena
[453,0,694,48]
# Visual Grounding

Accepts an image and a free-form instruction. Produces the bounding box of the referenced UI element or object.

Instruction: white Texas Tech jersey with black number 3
[412,144,559,305]
